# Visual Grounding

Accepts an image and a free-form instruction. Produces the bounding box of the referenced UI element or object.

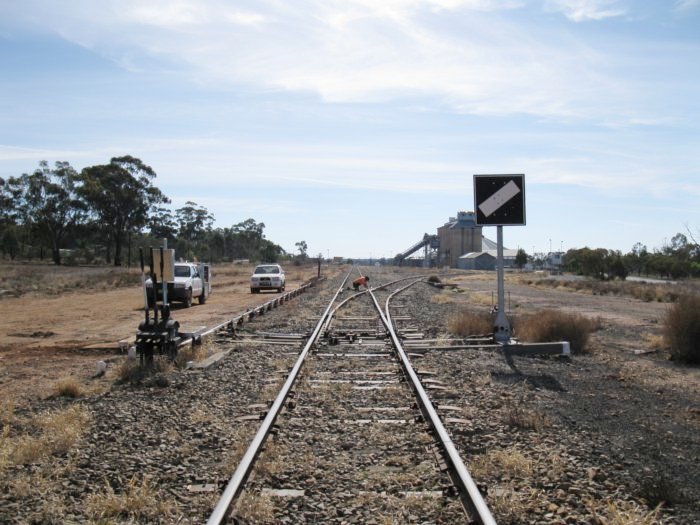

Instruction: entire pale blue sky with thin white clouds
[0,0,700,258]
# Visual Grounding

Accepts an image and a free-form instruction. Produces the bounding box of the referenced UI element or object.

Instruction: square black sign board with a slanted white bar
[474,175,525,226]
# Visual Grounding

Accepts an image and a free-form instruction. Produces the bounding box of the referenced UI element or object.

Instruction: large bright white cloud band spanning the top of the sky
[4,0,680,123]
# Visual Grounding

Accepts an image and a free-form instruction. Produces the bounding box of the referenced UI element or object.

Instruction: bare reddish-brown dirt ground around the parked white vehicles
[0,265,317,407]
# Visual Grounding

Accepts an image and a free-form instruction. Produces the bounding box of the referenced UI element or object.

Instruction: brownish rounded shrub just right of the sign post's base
[517,310,600,354]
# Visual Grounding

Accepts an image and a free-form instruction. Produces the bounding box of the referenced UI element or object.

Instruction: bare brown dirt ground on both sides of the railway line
[0,265,700,406]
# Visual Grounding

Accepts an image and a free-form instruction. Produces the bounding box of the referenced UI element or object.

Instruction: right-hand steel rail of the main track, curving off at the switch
[370,279,496,525]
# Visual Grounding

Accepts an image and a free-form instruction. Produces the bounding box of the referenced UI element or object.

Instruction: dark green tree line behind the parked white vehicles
[0,156,288,266]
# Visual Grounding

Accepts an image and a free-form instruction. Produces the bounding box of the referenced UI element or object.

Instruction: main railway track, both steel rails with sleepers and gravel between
[208,270,495,524]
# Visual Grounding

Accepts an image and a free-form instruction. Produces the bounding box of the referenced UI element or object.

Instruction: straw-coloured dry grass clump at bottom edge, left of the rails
[85,476,177,523]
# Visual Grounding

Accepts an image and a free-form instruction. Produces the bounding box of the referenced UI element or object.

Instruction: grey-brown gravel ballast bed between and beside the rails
[0,268,697,525]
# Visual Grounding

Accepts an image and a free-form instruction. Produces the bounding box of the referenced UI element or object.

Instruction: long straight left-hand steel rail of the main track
[207,272,350,525]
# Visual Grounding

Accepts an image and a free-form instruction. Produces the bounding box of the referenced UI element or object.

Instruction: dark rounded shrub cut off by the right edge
[664,295,700,364]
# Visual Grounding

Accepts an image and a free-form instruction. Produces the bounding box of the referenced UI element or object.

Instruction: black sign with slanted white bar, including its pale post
[474,175,525,344]
